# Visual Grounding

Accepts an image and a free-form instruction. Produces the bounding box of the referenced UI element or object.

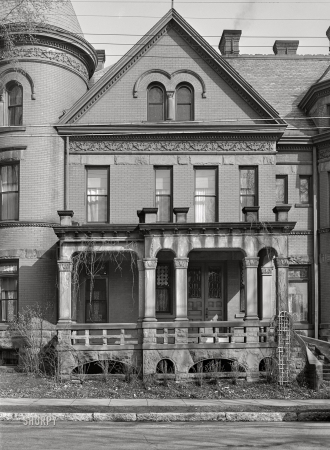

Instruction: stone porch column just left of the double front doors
[174,258,189,321]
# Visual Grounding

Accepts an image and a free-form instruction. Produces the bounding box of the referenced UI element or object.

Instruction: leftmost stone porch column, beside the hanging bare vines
[57,261,72,323]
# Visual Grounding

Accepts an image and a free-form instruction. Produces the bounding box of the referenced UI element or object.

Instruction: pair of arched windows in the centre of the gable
[148,83,194,122]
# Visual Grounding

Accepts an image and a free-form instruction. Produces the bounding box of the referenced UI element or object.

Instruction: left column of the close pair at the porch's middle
[143,258,157,322]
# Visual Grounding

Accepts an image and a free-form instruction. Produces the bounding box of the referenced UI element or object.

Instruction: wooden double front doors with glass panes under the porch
[188,262,225,321]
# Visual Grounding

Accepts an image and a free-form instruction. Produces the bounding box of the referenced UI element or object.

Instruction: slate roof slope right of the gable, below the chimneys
[226,55,330,135]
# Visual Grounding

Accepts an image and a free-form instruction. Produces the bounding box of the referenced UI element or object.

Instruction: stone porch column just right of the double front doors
[243,257,259,320]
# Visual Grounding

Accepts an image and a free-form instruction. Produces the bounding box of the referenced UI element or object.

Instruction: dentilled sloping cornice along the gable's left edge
[69,25,169,123]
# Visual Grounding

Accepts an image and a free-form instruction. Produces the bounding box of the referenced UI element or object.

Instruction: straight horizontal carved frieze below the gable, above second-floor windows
[70,140,276,153]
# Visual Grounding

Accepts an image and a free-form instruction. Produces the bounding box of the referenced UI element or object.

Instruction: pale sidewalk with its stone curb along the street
[0,398,330,422]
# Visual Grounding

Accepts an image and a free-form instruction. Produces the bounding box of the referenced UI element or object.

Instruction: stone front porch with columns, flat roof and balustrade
[55,216,294,377]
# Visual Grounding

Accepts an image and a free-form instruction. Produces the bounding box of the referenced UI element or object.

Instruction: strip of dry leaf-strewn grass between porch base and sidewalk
[0,373,330,399]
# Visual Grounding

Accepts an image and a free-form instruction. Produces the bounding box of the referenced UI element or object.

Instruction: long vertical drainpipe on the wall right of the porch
[313,146,319,339]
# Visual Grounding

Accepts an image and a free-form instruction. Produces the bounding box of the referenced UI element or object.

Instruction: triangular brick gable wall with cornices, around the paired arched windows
[60,10,284,125]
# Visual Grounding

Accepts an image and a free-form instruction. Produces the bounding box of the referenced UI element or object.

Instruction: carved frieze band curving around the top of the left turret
[0,47,89,80]
